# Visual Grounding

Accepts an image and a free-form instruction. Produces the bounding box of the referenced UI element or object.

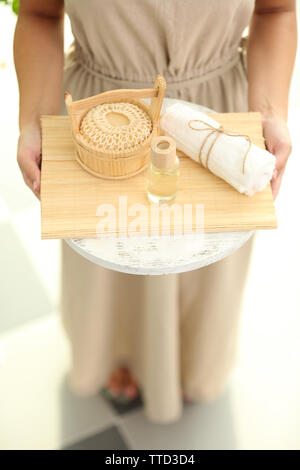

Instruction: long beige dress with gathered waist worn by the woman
[61,0,254,423]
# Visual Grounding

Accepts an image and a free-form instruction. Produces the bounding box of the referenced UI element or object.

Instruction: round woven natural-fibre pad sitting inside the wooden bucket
[80,101,153,155]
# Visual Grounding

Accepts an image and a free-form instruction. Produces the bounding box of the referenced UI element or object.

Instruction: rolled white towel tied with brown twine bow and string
[159,103,276,196]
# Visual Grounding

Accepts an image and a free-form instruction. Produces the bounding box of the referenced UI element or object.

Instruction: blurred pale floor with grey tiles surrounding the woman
[0,4,300,449]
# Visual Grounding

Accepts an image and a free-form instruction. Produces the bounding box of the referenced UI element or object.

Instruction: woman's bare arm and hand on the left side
[14,0,64,196]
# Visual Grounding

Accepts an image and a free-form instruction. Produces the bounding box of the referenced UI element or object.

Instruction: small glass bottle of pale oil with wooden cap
[147,135,180,204]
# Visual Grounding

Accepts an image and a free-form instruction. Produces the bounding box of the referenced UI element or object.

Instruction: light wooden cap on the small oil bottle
[151,135,176,168]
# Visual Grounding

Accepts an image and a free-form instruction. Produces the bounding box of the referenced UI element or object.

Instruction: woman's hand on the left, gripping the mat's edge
[17,125,41,198]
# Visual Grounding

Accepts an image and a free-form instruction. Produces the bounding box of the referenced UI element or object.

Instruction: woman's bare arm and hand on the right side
[247,0,297,198]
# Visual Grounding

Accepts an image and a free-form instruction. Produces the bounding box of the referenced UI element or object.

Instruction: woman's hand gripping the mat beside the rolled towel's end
[262,115,292,200]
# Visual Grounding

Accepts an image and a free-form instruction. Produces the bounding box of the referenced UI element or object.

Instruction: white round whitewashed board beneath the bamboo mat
[65,98,254,275]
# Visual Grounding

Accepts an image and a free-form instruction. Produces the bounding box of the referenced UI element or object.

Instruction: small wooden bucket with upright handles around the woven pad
[65,74,166,179]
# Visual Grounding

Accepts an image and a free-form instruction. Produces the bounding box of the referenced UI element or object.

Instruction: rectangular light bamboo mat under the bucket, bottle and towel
[41,113,277,239]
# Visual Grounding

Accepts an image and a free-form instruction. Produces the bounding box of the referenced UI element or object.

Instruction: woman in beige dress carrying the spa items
[14,0,297,423]
